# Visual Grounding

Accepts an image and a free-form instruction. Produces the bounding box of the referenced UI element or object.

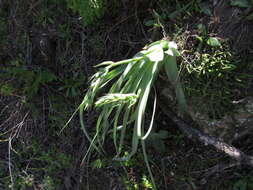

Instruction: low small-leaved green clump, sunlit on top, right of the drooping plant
[184,47,244,118]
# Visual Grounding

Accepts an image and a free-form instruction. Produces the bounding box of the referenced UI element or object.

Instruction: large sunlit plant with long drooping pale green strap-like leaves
[79,40,186,189]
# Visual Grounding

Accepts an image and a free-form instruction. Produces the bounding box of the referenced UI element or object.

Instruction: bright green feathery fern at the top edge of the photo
[67,0,106,25]
